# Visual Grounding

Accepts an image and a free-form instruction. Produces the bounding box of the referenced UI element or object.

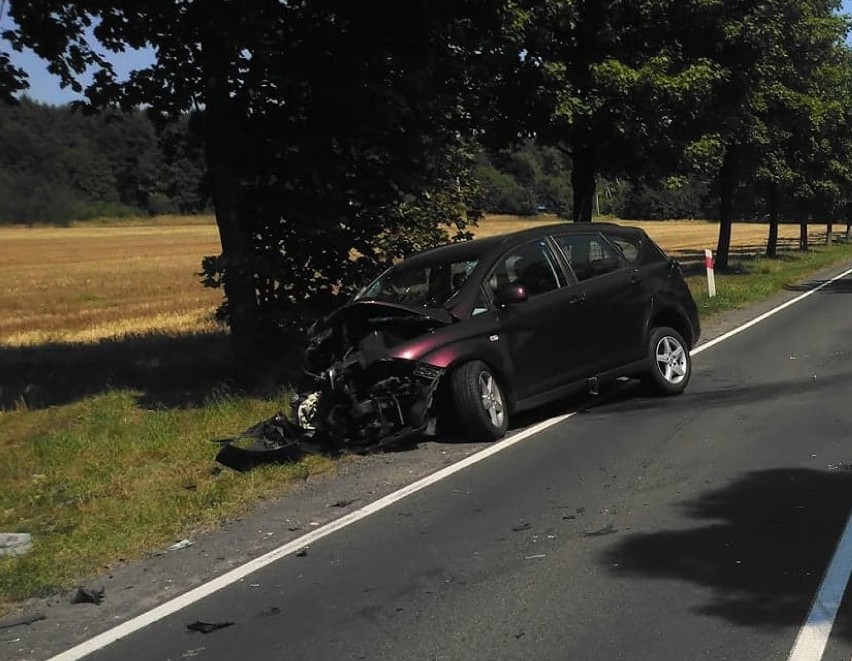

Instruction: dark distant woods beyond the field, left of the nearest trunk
[0,98,205,224]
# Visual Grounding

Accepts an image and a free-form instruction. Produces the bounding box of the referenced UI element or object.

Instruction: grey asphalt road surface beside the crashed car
[65,279,852,661]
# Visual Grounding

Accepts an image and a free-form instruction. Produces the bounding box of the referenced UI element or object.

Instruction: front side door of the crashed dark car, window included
[487,238,579,399]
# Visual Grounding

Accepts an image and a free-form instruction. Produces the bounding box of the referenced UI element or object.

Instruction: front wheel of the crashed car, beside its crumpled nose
[450,360,509,441]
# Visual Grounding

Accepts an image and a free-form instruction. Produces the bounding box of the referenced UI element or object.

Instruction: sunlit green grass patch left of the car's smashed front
[0,390,331,610]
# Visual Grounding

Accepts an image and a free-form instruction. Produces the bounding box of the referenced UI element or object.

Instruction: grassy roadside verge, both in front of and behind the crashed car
[0,231,852,614]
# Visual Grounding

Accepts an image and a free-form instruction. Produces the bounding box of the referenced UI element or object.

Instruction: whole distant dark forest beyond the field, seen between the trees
[0,98,732,224]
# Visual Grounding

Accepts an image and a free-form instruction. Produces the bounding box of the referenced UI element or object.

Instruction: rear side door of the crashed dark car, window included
[553,232,648,376]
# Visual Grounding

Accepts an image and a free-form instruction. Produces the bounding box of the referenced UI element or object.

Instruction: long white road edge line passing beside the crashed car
[48,269,852,661]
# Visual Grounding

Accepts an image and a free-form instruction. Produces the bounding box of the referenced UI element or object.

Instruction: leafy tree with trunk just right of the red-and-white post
[672,0,845,269]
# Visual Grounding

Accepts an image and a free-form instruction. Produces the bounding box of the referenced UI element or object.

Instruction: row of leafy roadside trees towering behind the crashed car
[0,0,852,382]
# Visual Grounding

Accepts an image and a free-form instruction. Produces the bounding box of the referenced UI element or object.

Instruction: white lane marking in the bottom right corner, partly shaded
[787,516,852,661]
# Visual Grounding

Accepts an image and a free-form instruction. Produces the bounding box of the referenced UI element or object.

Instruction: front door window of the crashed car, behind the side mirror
[488,239,565,297]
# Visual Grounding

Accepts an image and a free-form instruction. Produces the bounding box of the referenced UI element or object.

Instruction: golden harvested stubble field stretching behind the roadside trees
[0,215,822,346]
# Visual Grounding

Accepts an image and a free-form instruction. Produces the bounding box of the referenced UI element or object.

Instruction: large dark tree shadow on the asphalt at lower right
[601,465,852,639]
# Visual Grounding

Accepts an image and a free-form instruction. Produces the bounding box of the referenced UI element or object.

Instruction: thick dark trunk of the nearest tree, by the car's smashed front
[202,19,261,385]
